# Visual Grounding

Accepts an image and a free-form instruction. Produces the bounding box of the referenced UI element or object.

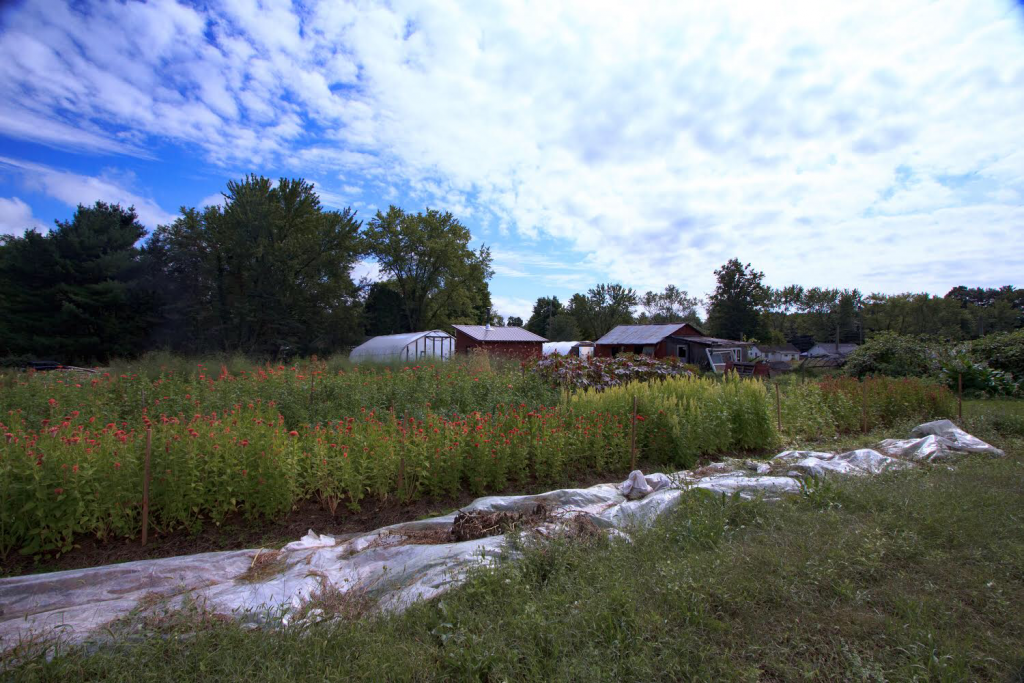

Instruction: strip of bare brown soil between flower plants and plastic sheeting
[0,463,664,578]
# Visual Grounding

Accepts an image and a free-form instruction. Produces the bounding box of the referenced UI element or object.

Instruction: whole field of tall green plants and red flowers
[0,358,953,572]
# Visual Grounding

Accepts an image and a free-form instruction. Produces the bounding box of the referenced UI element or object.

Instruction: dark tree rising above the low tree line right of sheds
[708,258,768,339]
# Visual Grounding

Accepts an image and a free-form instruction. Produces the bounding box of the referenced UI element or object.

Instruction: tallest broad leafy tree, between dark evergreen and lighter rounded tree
[154,175,361,355]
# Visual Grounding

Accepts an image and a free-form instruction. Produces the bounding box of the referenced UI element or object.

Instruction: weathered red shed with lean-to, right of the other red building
[594,323,753,373]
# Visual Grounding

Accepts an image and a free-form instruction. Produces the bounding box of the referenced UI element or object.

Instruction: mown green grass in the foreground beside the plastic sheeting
[8,401,1024,682]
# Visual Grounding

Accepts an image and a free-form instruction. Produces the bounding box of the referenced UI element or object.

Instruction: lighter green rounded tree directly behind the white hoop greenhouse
[364,206,493,331]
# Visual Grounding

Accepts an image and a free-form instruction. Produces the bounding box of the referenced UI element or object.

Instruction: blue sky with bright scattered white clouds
[0,0,1024,319]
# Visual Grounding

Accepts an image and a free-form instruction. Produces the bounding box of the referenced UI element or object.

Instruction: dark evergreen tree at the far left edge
[0,202,158,362]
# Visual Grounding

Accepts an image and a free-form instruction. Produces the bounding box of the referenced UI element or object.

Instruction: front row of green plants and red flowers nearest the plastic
[0,374,951,556]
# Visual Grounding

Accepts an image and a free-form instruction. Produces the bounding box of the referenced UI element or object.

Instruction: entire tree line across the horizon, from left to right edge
[0,175,1024,362]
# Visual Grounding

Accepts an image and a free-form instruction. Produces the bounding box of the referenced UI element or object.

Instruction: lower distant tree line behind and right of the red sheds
[525,259,1024,344]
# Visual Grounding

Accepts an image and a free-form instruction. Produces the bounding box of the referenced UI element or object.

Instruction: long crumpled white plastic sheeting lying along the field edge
[0,421,1002,652]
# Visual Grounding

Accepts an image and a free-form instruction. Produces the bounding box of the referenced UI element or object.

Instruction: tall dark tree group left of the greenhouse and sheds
[0,175,493,362]
